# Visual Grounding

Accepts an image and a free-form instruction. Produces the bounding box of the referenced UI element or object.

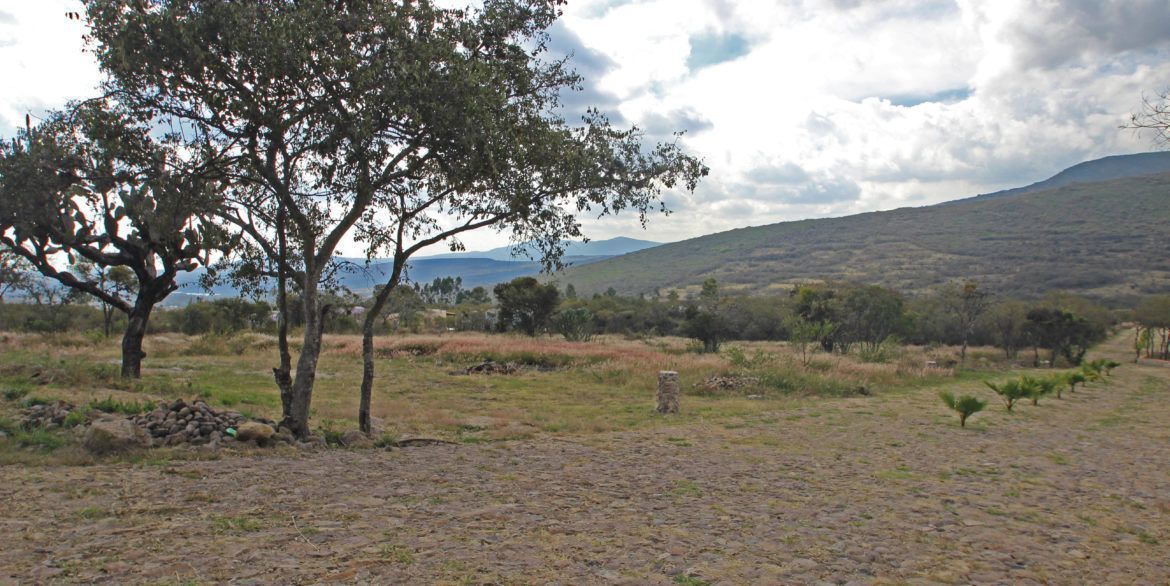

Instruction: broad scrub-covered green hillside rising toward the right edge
[557,153,1170,303]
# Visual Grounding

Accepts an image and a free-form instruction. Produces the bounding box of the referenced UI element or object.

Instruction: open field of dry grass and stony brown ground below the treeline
[0,333,1170,585]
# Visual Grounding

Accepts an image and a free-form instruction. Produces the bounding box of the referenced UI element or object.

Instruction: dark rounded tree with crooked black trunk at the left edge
[0,99,226,378]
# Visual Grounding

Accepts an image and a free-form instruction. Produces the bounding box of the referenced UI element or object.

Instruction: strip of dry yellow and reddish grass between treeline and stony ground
[0,333,1006,443]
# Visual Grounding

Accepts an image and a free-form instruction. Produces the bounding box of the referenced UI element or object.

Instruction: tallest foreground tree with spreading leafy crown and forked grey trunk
[87,0,704,435]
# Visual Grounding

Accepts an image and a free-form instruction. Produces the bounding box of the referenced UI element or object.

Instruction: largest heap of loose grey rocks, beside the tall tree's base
[131,399,293,447]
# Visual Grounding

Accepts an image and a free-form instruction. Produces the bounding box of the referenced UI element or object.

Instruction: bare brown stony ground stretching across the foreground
[0,341,1170,585]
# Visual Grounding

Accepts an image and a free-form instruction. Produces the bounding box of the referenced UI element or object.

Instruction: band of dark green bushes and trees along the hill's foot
[0,270,1170,365]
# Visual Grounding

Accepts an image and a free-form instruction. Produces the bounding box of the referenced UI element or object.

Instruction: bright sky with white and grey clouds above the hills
[0,0,1170,254]
